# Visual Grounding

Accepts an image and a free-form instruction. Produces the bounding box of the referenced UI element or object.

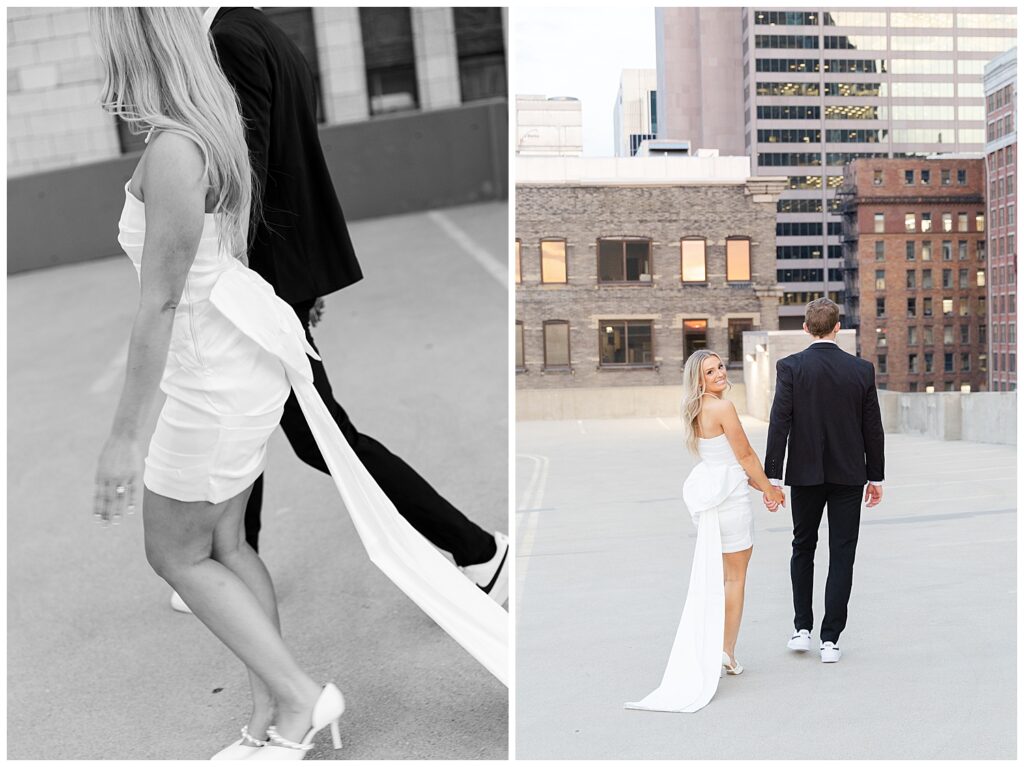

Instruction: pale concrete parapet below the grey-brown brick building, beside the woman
[515,383,746,421]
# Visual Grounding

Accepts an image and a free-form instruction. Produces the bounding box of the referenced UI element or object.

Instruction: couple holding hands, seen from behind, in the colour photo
[626,298,885,713]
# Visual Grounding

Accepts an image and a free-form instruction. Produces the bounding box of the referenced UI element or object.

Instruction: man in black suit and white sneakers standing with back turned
[765,298,885,663]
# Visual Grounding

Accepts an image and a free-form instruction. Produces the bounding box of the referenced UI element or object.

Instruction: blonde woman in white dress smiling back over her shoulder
[626,349,785,713]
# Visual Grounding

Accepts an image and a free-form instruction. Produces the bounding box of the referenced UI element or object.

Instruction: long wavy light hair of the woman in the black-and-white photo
[91,7,254,261]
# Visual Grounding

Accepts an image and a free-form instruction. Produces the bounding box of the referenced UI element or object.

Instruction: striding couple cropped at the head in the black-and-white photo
[92,7,508,759]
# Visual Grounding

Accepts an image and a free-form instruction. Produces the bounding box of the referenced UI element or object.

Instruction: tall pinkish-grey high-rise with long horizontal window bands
[656,7,1017,329]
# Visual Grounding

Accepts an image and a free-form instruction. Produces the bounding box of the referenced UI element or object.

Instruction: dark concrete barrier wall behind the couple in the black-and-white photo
[7,98,508,274]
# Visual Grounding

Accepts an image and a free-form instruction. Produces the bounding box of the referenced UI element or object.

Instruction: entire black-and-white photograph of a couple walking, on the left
[6,6,514,761]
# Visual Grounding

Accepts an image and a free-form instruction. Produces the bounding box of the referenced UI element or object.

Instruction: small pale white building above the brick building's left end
[515,95,583,157]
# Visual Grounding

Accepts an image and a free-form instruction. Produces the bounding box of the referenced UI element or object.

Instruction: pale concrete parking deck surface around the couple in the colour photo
[516,419,1017,760]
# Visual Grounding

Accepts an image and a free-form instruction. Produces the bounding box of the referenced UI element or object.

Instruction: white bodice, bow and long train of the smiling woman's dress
[626,435,750,714]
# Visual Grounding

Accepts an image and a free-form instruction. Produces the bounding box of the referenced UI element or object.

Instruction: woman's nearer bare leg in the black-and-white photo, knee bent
[142,489,321,740]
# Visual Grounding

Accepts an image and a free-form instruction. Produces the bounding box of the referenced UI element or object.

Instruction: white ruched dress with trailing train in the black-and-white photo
[118,184,508,685]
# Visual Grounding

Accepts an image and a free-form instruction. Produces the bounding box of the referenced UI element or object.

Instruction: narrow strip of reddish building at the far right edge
[985,48,1017,391]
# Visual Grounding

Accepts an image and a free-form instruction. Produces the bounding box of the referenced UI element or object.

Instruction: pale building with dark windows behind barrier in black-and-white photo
[7,7,508,177]
